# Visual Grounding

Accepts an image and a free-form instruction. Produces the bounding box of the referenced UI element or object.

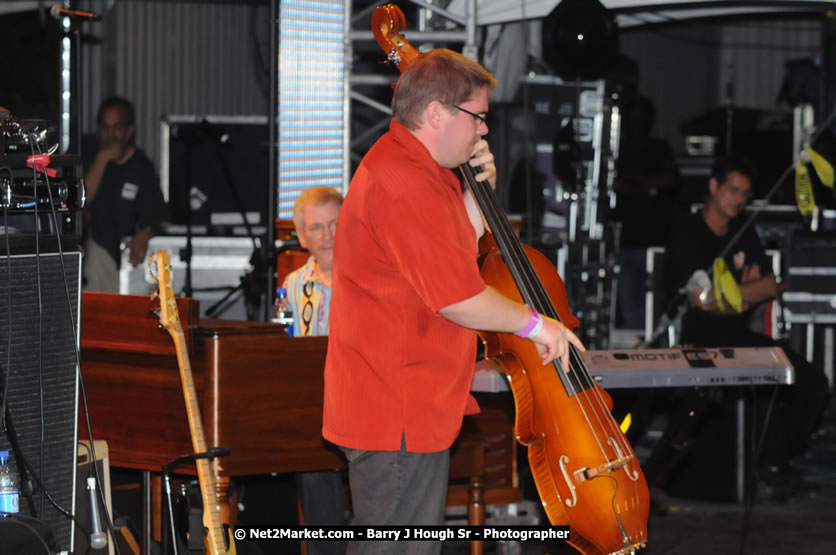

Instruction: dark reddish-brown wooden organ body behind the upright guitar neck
[79,292,345,477]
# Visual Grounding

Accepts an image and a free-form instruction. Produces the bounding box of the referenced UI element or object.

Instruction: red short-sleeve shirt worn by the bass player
[323,120,485,453]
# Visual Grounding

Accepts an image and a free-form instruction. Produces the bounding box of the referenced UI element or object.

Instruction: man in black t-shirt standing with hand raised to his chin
[82,97,167,292]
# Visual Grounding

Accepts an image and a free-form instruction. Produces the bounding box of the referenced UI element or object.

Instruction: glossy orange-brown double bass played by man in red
[372,4,650,554]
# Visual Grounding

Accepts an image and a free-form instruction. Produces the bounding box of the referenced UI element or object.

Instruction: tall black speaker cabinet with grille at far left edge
[0,233,81,551]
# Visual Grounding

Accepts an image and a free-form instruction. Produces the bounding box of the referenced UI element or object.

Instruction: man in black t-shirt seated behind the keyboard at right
[664,155,829,494]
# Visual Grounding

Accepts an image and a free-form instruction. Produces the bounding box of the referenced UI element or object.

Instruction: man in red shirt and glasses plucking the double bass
[323,49,583,553]
